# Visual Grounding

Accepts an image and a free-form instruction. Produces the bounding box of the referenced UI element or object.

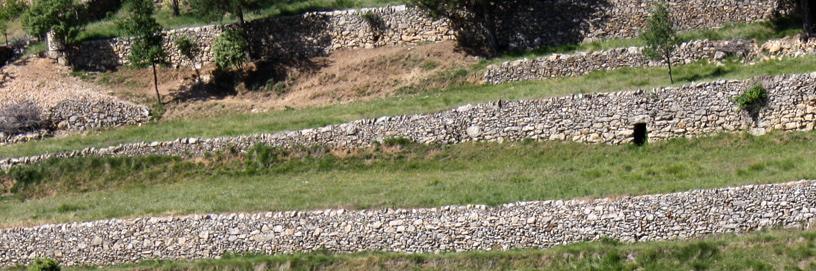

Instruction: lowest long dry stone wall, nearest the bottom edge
[0,181,816,266]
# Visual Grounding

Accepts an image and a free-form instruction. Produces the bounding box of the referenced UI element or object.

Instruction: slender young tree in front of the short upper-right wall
[641,2,679,83]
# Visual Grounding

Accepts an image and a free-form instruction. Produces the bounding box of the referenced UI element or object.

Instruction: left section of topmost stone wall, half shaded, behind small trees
[71,6,454,70]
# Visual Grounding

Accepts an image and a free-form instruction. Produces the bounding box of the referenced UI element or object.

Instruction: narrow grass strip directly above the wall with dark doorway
[0,57,816,160]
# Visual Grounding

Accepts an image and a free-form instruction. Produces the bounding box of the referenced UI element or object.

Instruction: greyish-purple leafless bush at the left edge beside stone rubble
[0,101,43,134]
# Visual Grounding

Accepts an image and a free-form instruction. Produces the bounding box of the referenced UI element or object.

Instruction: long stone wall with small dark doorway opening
[0,73,816,169]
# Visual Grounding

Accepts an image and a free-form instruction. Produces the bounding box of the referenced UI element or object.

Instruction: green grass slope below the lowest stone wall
[52,228,816,271]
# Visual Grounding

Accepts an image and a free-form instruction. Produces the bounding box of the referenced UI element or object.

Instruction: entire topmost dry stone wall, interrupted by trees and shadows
[70,0,789,69]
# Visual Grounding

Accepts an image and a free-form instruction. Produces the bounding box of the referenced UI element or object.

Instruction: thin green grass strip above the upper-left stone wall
[78,0,404,41]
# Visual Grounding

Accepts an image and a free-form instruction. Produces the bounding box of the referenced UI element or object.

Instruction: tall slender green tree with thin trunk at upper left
[119,0,167,105]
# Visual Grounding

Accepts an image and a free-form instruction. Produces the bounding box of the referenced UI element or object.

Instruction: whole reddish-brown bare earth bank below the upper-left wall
[76,42,478,119]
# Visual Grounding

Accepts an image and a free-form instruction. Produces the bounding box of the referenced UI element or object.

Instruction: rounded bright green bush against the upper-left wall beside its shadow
[212,29,247,69]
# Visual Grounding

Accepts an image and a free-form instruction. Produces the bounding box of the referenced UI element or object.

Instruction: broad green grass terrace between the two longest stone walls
[0,132,816,228]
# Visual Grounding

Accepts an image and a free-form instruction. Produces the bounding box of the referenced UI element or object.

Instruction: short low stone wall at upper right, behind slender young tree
[484,37,816,84]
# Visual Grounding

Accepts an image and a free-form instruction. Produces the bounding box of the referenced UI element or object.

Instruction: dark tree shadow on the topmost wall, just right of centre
[453,0,611,55]
